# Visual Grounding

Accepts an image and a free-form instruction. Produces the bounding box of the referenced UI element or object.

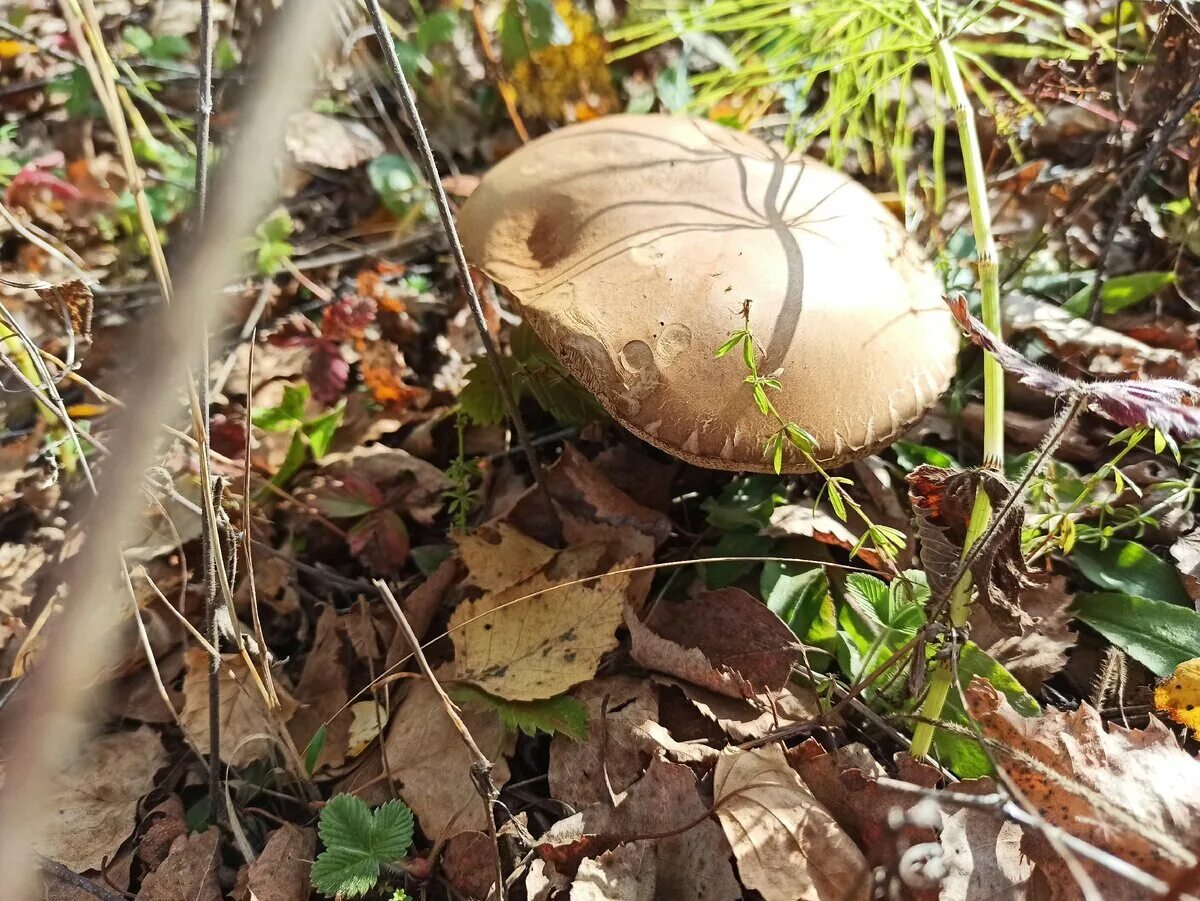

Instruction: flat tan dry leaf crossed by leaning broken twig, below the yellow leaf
[384,680,511,841]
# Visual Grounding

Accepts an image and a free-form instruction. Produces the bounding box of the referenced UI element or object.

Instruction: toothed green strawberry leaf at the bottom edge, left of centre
[312,794,413,897]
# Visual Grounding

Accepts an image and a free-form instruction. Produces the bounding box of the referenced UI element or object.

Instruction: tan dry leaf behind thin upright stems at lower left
[180,648,296,767]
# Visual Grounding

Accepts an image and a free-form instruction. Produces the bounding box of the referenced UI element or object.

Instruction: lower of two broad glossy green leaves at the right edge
[1073,591,1200,677]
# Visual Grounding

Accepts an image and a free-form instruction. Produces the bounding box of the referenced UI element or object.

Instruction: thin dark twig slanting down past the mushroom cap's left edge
[364,0,557,519]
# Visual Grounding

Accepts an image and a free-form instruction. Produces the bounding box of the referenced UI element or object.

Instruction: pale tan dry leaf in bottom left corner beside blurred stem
[35,726,167,872]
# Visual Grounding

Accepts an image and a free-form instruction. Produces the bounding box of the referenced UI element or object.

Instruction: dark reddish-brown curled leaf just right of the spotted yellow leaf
[625,588,799,698]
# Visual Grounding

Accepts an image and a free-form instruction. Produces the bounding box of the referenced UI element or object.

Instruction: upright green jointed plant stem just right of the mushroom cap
[910,14,1004,759]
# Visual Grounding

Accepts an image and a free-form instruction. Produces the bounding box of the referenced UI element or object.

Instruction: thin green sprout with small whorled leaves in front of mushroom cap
[716,300,908,561]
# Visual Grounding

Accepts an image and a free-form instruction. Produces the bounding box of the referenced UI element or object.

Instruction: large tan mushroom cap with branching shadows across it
[458,115,959,471]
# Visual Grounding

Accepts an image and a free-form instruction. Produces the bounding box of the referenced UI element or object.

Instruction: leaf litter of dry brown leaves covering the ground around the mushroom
[7,2,1200,901]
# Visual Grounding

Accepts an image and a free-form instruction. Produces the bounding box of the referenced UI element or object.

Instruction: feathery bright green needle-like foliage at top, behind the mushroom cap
[611,0,1108,187]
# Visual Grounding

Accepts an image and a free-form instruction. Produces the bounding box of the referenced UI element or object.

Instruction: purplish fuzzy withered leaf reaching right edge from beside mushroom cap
[948,296,1200,440]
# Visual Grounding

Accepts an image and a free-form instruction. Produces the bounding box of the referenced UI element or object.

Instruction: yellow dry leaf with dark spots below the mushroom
[450,545,630,701]
